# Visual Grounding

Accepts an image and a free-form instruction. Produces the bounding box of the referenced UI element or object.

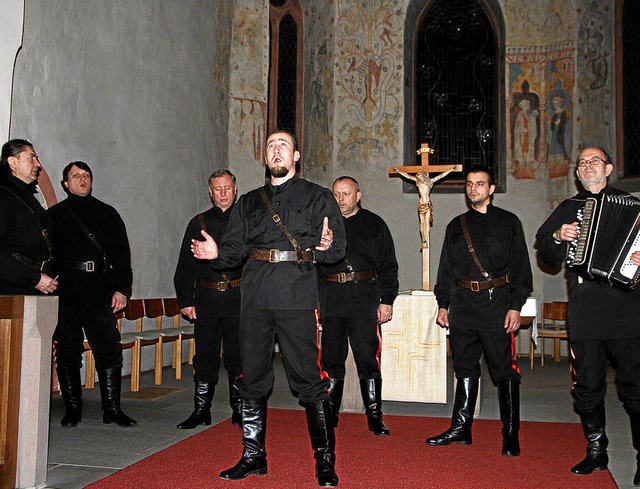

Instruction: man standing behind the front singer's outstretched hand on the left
[173,170,242,429]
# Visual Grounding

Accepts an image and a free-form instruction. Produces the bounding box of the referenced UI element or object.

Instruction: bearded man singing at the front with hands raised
[192,130,346,487]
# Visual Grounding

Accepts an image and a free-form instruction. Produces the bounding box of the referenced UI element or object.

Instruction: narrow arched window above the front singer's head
[268,0,303,148]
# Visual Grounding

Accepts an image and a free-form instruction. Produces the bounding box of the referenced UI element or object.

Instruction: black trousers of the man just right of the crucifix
[450,328,522,383]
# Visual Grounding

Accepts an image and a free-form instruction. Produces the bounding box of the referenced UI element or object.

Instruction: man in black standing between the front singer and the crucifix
[320,176,398,436]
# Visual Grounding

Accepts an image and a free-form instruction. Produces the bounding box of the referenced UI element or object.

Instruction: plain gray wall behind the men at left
[10,0,229,297]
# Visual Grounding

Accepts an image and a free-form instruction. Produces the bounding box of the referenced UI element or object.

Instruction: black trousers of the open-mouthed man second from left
[53,299,122,370]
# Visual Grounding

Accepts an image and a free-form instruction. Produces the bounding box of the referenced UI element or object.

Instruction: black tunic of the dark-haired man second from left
[48,194,132,302]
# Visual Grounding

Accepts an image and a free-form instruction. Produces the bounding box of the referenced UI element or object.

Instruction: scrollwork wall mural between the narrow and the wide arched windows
[335,0,404,165]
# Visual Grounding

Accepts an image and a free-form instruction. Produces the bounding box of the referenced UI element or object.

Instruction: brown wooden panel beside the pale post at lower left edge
[0,296,24,489]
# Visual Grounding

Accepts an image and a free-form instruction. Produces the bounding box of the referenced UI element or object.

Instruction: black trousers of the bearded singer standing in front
[238,308,329,402]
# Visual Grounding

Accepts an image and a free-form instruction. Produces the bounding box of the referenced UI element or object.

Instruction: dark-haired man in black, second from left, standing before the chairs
[48,161,136,427]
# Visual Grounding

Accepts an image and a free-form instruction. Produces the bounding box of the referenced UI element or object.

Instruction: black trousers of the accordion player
[571,338,640,415]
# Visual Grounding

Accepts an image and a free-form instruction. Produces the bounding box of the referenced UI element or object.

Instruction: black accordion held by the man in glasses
[567,195,640,288]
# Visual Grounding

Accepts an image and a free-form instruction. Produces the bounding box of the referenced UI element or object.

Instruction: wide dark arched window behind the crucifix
[405,0,506,191]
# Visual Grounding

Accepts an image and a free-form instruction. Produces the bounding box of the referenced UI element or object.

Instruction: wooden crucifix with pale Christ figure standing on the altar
[389,143,462,290]
